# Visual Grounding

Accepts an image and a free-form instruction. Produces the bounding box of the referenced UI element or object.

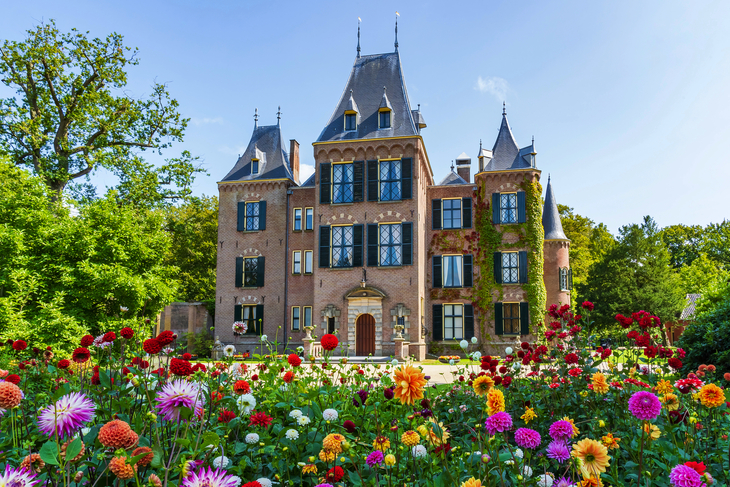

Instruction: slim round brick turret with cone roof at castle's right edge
[542,177,573,306]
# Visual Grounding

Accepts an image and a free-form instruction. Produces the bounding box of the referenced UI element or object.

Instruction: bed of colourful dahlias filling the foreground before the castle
[0,303,730,487]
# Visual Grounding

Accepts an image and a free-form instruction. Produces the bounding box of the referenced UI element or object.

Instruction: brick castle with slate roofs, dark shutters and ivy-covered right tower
[215,33,572,360]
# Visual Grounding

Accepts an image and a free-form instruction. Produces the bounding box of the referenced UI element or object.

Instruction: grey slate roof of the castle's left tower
[223,125,294,181]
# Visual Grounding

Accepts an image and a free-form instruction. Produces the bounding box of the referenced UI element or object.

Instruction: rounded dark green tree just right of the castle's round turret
[578,216,684,331]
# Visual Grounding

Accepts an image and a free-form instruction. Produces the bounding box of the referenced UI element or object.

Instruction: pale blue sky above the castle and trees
[0,0,730,232]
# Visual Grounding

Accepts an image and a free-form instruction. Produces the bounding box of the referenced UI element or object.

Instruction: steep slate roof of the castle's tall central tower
[317,52,418,142]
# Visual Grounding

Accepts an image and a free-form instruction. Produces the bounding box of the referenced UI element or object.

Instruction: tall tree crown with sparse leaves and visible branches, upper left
[0,21,188,199]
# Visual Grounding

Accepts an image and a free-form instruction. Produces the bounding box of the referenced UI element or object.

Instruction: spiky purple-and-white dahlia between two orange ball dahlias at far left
[38,392,96,438]
